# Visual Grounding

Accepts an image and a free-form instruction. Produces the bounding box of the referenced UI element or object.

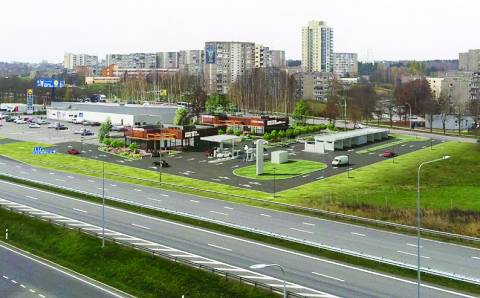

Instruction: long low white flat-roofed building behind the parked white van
[305,128,390,153]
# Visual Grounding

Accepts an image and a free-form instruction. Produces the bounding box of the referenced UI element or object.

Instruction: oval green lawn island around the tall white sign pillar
[233,160,327,180]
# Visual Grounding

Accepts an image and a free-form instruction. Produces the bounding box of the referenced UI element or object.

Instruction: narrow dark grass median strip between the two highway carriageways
[0,175,480,295]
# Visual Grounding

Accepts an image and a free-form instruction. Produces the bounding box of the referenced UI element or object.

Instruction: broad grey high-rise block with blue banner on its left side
[204,41,255,94]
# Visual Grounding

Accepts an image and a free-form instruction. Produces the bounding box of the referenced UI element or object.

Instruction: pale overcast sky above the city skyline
[0,0,480,62]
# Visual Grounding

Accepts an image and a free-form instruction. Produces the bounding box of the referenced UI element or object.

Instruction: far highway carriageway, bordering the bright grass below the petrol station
[0,159,480,280]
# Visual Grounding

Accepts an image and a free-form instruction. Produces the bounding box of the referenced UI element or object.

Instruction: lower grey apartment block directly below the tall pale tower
[294,72,335,101]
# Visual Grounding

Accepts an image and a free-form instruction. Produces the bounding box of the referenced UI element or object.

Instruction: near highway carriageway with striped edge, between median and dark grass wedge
[0,183,470,297]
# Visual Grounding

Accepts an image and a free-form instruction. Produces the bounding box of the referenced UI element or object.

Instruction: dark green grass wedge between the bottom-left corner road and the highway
[0,208,277,298]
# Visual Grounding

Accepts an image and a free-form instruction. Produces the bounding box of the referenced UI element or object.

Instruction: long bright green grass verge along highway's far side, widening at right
[0,142,480,236]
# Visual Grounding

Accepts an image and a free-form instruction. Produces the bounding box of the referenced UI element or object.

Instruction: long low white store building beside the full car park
[47,102,178,126]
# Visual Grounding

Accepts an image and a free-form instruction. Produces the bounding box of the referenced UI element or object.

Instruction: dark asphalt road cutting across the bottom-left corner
[0,244,124,298]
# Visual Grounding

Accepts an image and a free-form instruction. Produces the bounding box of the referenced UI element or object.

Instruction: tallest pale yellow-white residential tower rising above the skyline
[302,21,334,72]
